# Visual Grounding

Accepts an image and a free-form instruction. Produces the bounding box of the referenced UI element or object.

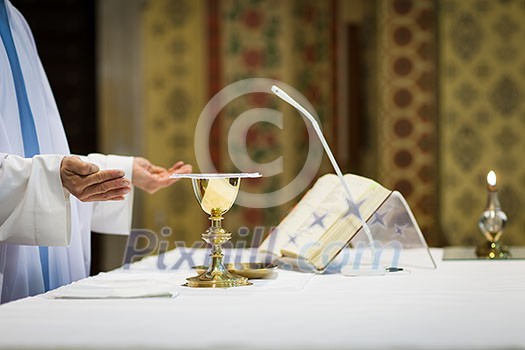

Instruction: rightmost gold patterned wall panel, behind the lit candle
[439,0,525,245]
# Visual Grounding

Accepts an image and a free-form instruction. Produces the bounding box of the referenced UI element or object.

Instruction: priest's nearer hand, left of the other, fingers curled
[60,156,131,202]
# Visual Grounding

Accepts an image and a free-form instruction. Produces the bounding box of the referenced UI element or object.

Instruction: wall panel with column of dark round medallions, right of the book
[369,0,443,245]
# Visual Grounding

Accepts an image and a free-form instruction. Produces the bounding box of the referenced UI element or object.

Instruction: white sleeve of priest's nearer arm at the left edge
[0,153,71,246]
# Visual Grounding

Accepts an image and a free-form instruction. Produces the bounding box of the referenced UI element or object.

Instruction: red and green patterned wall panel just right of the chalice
[219,0,287,232]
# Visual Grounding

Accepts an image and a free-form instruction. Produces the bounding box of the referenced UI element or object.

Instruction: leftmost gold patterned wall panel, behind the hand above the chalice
[143,0,207,244]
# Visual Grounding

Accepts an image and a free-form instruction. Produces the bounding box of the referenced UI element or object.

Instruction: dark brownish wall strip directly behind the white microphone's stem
[287,0,336,180]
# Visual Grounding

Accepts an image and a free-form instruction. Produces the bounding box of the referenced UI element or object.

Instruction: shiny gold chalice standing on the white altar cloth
[184,177,251,288]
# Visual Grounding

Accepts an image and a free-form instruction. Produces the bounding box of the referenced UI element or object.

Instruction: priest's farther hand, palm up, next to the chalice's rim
[132,157,192,193]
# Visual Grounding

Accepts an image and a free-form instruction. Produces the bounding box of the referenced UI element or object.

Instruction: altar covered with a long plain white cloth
[0,249,525,349]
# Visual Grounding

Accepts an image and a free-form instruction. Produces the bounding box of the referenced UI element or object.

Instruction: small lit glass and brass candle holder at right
[476,171,510,259]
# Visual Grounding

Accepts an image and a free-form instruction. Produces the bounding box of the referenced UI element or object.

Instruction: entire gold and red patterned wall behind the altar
[100,0,525,250]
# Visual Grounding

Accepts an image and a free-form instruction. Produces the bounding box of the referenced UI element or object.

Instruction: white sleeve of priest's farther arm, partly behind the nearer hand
[83,153,133,235]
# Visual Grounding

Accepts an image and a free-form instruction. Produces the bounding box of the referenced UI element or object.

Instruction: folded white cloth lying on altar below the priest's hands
[45,273,179,299]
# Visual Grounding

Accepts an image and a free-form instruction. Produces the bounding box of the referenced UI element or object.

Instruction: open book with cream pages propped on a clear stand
[259,174,392,271]
